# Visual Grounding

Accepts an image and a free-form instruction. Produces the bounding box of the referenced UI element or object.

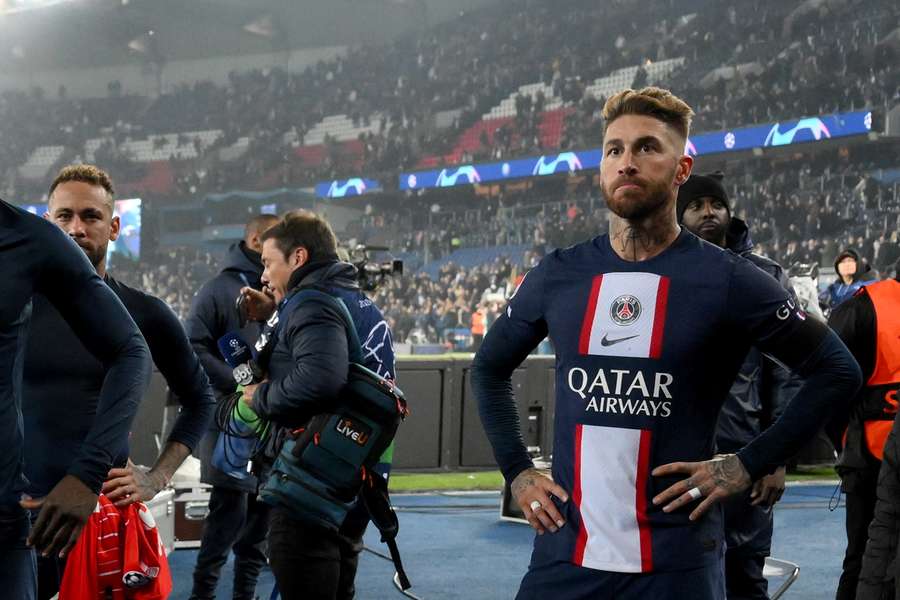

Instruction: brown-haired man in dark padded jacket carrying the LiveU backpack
[243,210,394,600]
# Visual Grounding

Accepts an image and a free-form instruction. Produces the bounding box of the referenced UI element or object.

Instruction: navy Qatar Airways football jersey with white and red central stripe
[482,231,806,573]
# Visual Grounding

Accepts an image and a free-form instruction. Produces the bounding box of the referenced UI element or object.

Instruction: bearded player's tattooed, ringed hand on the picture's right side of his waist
[652,454,753,521]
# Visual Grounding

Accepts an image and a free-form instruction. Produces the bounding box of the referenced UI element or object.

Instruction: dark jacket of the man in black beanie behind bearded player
[716,217,802,554]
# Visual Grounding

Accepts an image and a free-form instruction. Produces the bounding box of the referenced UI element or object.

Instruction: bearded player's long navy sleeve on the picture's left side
[471,258,547,482]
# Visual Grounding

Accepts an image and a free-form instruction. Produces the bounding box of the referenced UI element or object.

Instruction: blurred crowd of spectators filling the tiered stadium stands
[0,0,900,340]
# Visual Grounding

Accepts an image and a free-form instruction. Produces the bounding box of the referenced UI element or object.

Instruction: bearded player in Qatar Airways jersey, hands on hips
[472,88,860,600]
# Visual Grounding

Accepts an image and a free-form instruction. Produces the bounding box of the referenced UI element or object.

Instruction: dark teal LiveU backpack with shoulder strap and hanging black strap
[260,288,410,590]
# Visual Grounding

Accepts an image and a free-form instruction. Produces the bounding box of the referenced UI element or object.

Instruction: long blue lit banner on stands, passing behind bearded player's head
[400,111,872,192]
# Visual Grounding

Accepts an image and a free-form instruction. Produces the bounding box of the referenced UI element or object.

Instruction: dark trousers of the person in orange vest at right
[836,458,881,600]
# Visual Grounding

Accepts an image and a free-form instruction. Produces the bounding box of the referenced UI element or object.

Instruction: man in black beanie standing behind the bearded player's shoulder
[676,172,801,599]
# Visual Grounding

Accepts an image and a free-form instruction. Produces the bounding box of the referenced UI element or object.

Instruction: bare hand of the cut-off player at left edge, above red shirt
[20,475,97,558]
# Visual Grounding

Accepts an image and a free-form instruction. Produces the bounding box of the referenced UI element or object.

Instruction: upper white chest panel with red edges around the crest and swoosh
[578,272,669,358]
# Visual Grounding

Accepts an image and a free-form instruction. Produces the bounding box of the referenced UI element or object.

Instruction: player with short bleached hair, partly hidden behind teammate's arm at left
[22,165,215,600]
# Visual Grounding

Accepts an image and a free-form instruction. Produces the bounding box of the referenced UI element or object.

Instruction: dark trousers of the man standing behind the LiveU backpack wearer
[191,486,269,600]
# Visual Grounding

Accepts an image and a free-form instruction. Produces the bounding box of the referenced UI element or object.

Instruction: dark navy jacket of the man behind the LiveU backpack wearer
[185,242,263,491]
